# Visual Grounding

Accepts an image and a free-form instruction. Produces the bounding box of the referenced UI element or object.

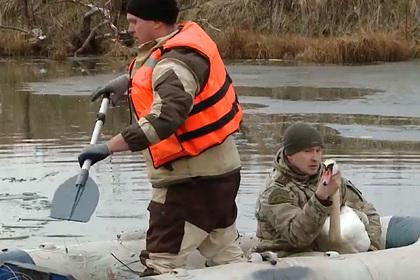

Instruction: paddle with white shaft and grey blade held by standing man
[50,97,109,223]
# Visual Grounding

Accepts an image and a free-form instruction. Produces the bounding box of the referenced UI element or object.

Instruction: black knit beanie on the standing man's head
[127,0,179,24]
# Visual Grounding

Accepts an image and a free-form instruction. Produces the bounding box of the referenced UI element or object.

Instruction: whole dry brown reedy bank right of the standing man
[184,0,420,63]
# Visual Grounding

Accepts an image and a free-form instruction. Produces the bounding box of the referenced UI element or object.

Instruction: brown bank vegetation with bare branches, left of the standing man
[0,0,126,59]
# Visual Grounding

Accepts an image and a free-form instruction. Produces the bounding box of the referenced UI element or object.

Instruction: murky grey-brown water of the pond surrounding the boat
[0,59,420,247]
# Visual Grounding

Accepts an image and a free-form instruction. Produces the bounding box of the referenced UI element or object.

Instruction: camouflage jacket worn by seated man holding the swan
[256,149,382,256]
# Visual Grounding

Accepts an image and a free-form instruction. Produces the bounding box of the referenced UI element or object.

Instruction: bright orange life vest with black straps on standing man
[130,22,242,168]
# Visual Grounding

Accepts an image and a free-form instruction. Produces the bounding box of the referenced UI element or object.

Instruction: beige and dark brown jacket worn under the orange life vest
[121,24,241,188]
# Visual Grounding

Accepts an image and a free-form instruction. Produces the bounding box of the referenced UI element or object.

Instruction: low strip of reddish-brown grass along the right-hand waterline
[216,28,419,64]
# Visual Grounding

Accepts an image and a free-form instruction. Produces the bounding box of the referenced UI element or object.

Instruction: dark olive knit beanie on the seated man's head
[283,123,323,156]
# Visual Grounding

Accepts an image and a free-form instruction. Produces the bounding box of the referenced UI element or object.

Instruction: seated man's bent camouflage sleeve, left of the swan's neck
[263,188,331,249]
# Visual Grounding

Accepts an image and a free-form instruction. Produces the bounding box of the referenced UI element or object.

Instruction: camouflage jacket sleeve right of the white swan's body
[343,180,383,251]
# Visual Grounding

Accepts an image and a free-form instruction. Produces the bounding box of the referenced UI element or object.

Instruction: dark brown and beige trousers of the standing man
[140,170,242,273]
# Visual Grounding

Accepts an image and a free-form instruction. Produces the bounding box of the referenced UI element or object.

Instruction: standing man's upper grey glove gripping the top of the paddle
[90,74,130,106]
